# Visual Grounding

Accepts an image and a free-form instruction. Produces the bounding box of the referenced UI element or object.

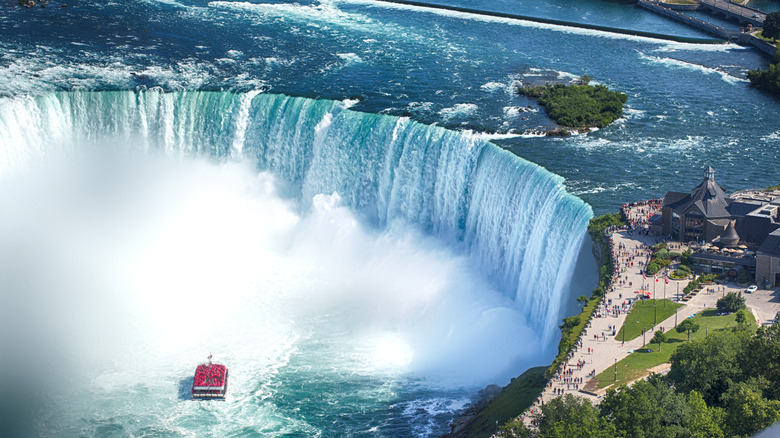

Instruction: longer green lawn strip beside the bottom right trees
[596,309,756,388]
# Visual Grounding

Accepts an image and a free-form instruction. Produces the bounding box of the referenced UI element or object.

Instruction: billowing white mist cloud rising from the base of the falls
[0,151,539,434]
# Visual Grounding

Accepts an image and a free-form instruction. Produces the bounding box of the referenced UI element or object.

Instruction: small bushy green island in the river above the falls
[518,76,628,128]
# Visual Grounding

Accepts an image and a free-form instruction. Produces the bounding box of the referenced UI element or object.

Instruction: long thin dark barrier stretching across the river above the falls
[368,0,725,44]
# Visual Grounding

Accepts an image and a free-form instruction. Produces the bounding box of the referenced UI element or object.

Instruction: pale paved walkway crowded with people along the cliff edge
[523,206,780,424]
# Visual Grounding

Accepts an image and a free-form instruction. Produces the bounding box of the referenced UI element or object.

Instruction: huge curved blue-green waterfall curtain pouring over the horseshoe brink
[0,90,592,344]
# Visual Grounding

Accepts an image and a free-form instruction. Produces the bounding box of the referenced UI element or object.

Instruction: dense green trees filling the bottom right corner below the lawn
[501,323,780,438]
